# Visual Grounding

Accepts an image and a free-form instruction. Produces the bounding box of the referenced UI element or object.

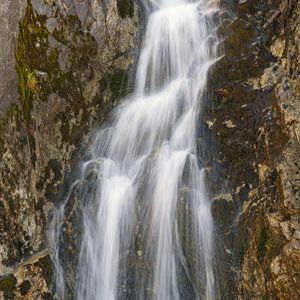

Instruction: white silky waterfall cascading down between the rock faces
[53,0,218,300]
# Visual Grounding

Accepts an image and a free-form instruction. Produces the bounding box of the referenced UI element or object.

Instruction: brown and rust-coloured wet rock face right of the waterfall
[206,0,300,299]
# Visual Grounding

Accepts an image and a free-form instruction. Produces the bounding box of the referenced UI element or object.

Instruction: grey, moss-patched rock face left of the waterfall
[0,0,139,299]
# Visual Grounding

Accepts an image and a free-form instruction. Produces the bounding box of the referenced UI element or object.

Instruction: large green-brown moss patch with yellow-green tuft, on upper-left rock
[16,0,98,148]
